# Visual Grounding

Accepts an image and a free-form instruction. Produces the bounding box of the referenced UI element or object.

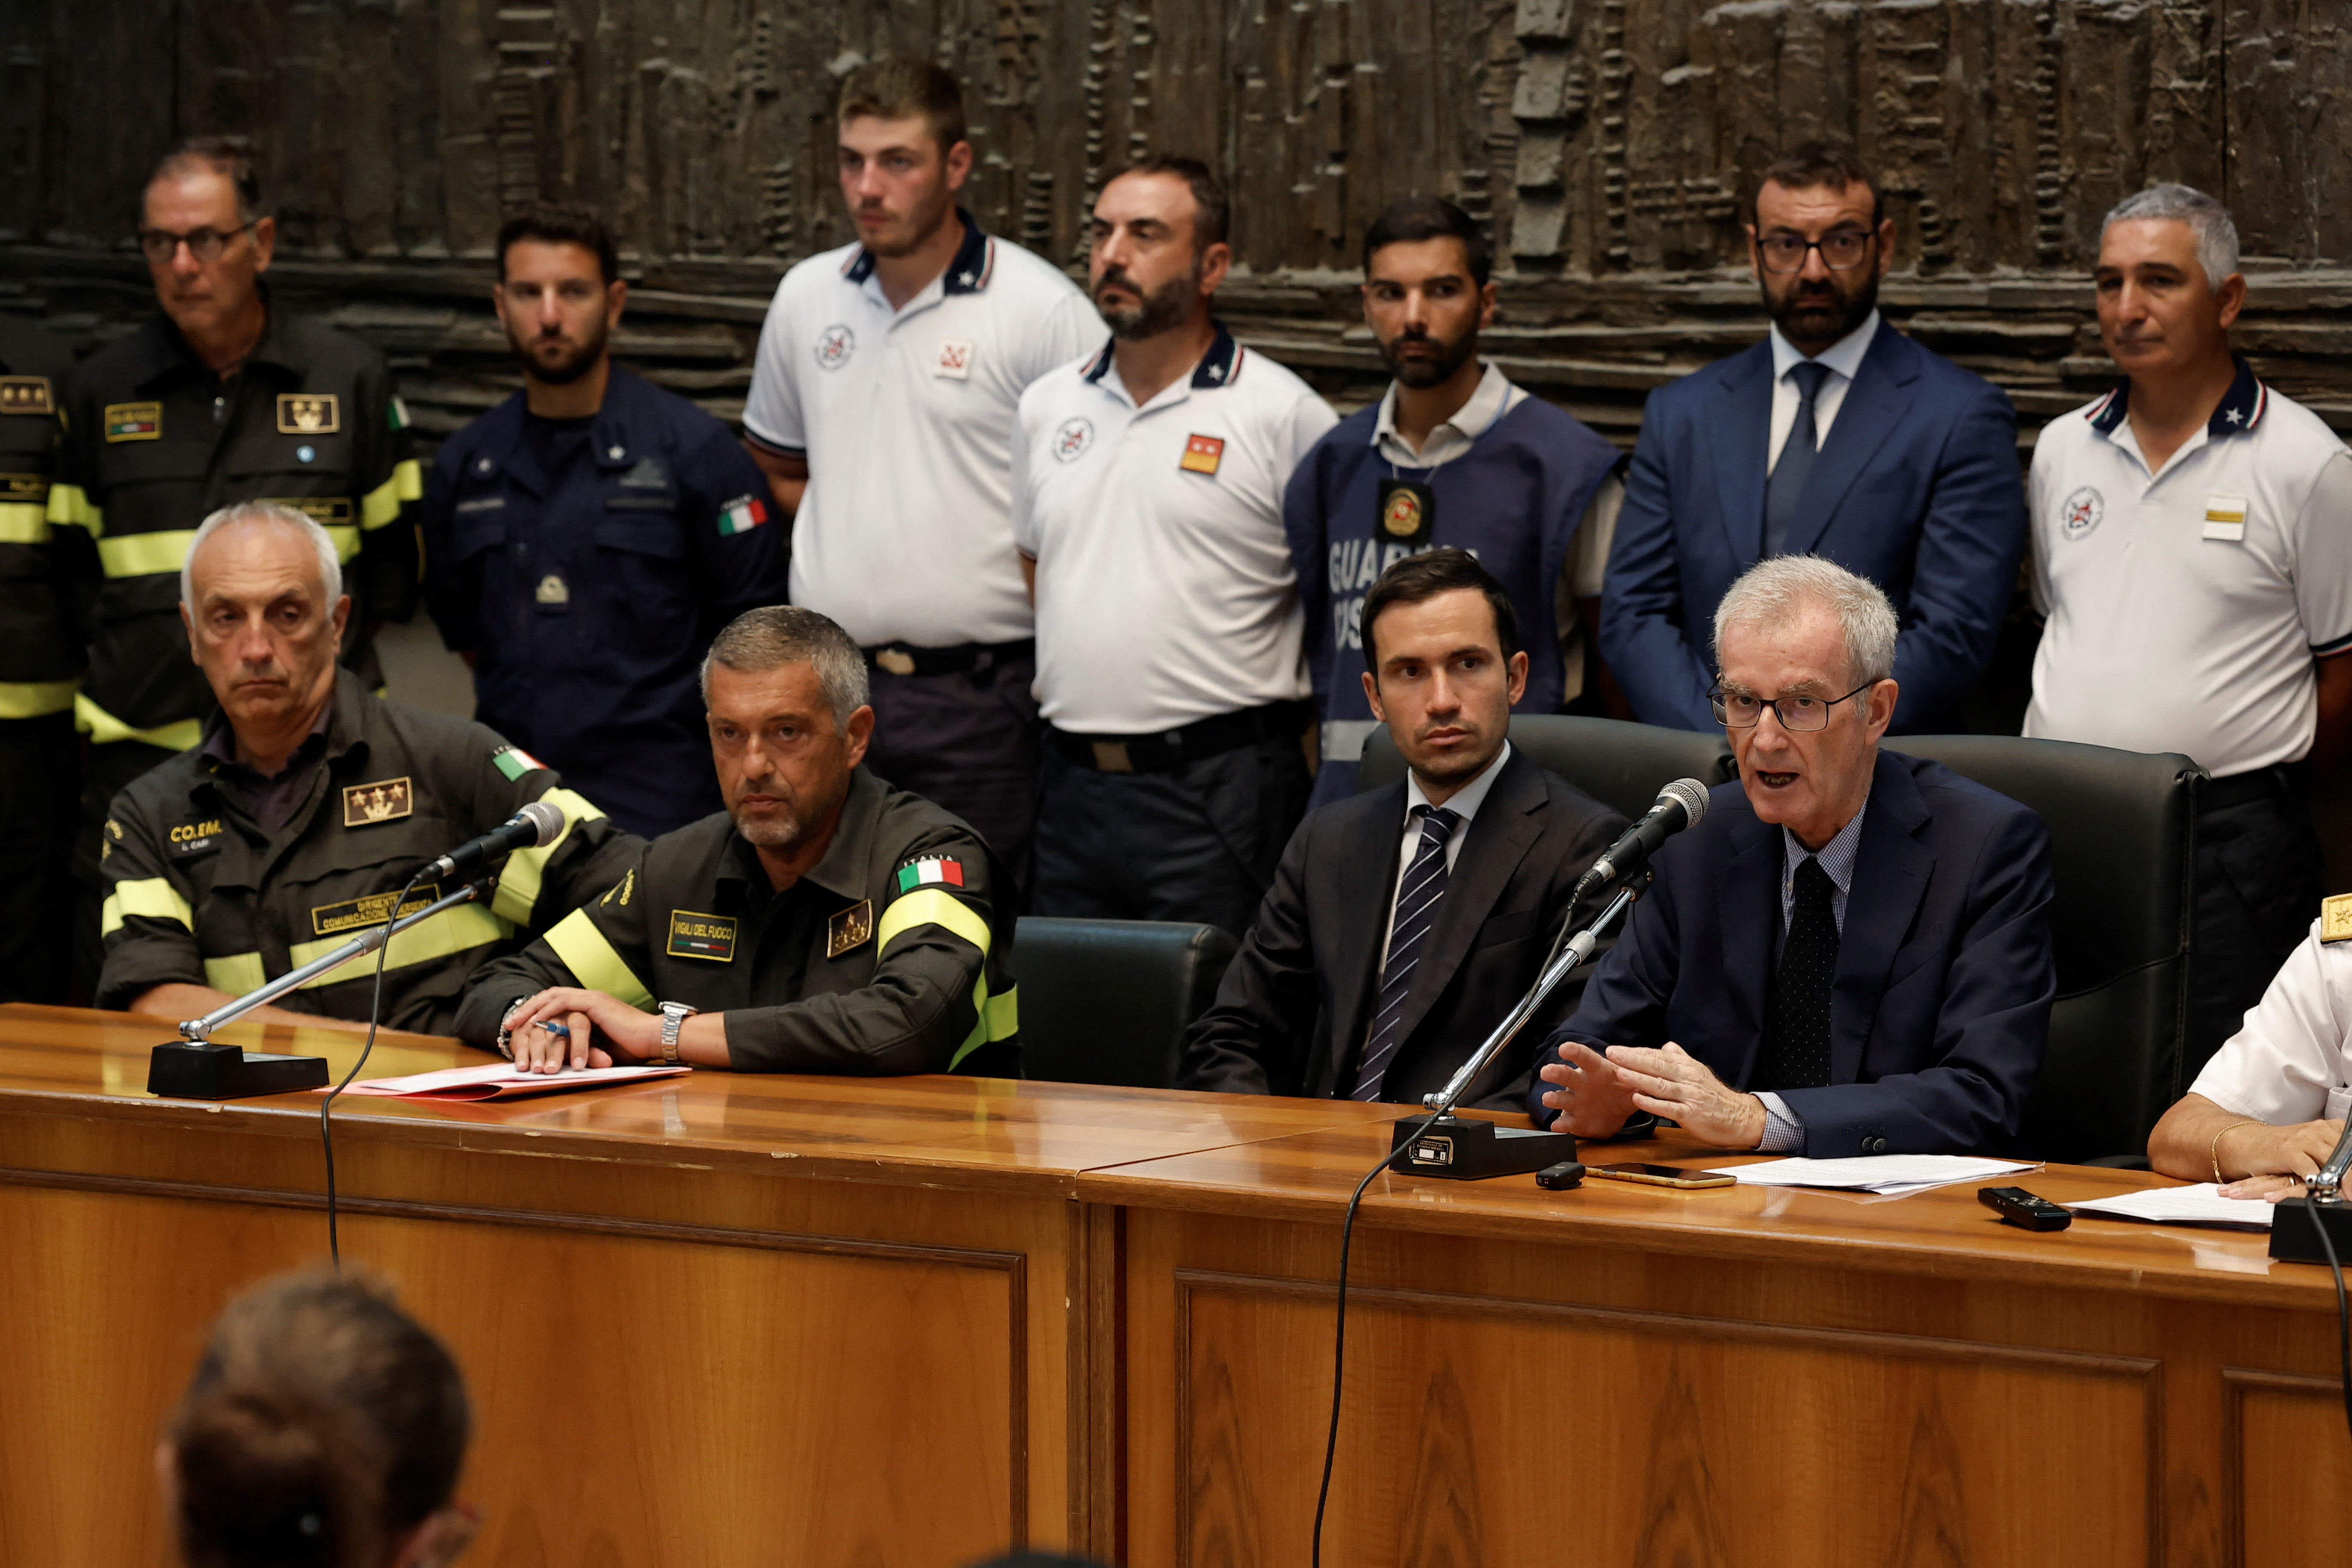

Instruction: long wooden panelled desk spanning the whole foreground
[0,1006,2352,1568]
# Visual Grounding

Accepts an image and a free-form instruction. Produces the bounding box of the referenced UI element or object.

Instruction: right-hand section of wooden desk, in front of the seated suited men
[1084,1133,2352,1568]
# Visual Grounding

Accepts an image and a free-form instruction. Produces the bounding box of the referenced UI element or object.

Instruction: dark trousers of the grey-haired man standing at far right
[2181,764,2326,1088]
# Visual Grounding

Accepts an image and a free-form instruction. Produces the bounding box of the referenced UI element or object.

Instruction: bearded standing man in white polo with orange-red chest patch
[1014,155,1339,936]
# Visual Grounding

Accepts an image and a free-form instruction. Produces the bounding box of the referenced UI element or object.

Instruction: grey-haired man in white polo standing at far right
[2025,186,2352,1074]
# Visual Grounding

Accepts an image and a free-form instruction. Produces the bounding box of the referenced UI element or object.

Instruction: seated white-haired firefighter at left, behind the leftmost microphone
[97,501,638,1034]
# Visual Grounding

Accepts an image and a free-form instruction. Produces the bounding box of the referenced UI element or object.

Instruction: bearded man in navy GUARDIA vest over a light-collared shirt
[1282,195,1623,806]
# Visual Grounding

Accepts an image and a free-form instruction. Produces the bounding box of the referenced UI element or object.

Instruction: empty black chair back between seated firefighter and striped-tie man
[1011,915,1237,1088]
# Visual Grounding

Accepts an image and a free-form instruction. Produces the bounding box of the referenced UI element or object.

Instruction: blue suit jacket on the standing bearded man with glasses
[1602,322,2025,733]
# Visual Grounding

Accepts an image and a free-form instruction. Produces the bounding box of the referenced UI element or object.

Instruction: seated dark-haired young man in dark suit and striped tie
[1179,550,1625,1110]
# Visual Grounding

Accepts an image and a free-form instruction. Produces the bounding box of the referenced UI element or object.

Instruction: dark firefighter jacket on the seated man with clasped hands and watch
[459,769,1021,1077]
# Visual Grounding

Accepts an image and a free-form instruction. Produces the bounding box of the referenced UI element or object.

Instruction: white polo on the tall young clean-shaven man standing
[743,214,1103,649]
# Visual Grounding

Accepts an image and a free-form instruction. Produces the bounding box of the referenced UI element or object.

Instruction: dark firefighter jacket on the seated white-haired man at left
[97,675,638,1034]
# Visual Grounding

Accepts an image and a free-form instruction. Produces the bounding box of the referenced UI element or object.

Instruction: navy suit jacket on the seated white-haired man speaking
[1529,752,2058,1159]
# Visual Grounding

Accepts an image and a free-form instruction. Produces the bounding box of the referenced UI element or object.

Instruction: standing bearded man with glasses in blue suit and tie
[1599,141,2025,733]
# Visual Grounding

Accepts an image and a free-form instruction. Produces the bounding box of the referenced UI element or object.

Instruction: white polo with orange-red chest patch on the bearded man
[1014,327,1339,736]
